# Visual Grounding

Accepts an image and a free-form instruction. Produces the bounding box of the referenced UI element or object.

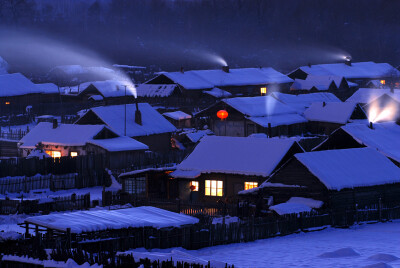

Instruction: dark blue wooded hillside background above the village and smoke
[0,0,400,70]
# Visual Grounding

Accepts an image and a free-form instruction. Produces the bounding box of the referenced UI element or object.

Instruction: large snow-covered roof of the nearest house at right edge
[295,148,400,191]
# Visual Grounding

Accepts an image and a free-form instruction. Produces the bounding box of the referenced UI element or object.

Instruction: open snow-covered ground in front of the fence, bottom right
[123,220,400,268]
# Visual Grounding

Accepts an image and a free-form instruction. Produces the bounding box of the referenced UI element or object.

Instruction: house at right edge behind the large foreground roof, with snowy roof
[314,122,400,166]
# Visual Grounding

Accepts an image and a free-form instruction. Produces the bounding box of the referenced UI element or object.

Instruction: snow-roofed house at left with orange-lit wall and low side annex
[19,121,148,168]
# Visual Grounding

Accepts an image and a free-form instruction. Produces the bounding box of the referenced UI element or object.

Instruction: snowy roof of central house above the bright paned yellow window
[171,136,295,178]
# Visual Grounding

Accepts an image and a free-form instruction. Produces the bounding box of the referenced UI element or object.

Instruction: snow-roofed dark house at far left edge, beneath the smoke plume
[0,73,59,114]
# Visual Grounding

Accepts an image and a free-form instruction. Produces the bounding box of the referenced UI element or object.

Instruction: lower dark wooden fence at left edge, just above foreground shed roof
[0,193,91,215]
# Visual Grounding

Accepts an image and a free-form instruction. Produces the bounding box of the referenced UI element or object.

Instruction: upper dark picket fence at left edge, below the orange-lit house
[0,173,77,194]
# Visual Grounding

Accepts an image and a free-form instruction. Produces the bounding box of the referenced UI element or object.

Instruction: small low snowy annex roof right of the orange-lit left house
[88,136,149,152]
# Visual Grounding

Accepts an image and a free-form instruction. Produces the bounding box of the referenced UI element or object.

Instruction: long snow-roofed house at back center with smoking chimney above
[145,66,293,107]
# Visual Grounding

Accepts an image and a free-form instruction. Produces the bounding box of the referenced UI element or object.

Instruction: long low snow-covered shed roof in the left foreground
[25,207,199,234]
